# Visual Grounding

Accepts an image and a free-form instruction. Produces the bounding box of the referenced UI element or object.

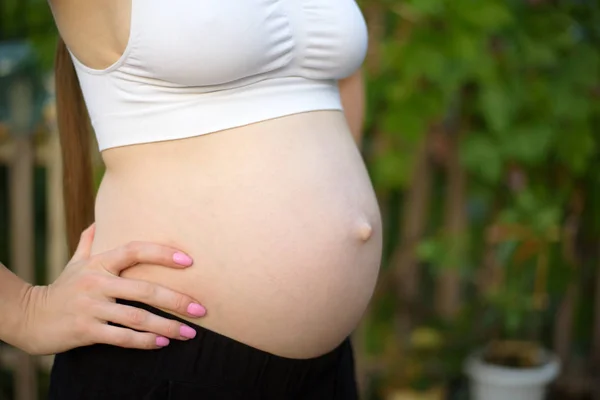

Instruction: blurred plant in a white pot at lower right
[465,199,560,400]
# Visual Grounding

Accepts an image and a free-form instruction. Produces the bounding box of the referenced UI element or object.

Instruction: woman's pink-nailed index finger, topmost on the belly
[96,242,193,275]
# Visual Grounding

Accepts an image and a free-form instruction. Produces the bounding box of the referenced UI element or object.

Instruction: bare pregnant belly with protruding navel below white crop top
[93,112,382,358]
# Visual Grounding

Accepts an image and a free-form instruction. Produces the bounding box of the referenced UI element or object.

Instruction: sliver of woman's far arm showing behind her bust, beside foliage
[339,69,365,145]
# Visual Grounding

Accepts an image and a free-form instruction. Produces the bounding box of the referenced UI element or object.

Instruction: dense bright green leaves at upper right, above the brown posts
[363,0,600,188]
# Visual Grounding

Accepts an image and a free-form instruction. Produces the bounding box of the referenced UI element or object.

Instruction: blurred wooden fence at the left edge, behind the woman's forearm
[0,96,68,400]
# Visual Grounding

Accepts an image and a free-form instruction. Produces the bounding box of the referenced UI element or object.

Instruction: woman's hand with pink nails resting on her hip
[18,225,205,354]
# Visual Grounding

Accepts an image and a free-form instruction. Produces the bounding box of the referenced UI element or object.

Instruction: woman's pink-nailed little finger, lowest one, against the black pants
[93,324,169,350]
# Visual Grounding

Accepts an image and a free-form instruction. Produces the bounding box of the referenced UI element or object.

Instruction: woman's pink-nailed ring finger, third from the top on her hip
[95,303,196,340]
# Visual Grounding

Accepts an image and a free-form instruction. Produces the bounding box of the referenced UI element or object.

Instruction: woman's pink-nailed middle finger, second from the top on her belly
[104,278,206,317]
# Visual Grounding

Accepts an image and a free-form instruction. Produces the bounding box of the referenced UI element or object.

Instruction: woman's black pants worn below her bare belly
[50,301,358,400]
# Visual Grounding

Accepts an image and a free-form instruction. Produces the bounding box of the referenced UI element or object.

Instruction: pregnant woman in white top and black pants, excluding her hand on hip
[50,0,382,400]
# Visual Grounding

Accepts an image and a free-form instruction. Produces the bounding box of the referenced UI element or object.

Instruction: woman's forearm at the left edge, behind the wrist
[0,264,32,347]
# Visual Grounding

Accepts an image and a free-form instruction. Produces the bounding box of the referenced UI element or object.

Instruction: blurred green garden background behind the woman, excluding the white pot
[0,0,600,400]
